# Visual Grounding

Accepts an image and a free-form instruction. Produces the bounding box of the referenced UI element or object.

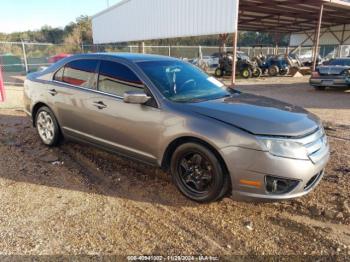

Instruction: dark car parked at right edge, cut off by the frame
[310,58,350,90]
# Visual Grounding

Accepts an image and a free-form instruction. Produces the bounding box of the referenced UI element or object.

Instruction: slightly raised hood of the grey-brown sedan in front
[186,93,319,137]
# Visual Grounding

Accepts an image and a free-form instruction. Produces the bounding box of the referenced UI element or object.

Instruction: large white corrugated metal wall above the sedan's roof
[92,0,239,44]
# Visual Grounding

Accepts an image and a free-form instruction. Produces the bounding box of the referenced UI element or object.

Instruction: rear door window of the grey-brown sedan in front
[61,59,98,88]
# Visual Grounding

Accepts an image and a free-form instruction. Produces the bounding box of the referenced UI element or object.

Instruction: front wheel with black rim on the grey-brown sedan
[170,143,230,203]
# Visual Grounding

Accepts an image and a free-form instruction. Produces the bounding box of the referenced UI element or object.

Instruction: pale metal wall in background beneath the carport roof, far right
[290,24,350,46]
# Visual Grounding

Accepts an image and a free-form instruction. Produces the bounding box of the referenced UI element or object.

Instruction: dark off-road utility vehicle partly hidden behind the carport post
[215,51,261,78]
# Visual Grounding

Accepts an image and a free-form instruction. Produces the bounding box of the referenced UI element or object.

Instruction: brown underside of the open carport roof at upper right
[239,0,350,33]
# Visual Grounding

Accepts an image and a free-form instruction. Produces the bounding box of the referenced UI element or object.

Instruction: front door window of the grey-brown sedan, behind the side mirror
[98,61,144,97]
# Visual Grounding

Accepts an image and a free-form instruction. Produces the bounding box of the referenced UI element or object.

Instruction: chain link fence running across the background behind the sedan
[0,42,350,85]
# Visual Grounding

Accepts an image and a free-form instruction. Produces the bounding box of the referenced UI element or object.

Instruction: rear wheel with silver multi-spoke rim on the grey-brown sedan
[35,106,60,147]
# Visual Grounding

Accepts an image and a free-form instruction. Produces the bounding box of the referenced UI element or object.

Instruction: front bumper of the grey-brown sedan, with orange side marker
[221,145,329,200]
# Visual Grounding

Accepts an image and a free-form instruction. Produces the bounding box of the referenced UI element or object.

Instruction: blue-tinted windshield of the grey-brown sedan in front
[137,61,235,103]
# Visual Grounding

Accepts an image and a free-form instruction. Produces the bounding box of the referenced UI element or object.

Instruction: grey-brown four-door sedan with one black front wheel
[24,53,329,202]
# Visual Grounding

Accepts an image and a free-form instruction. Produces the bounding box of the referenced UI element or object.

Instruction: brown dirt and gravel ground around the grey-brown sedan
[0,78,350,259]
